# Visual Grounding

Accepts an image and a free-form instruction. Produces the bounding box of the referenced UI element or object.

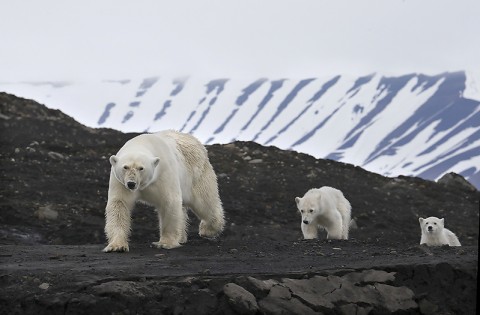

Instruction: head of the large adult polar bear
[110,154,160,191]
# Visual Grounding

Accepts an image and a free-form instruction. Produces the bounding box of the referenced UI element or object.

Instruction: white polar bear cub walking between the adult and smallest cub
[295,186,352,240]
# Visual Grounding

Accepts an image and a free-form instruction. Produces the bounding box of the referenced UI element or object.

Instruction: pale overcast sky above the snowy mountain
[0,0,480,82]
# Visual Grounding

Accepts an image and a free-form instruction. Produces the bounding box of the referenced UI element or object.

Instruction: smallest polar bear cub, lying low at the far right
[418,217,461,246]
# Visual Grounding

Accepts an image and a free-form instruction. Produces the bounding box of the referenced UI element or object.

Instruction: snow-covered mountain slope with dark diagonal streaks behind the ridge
[0,72,480,188]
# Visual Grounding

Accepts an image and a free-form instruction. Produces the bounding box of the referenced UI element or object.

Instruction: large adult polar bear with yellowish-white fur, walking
[103,130,225,252]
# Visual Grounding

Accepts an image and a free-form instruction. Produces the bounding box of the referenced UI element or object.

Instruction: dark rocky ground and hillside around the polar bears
[0,93,480,314]
